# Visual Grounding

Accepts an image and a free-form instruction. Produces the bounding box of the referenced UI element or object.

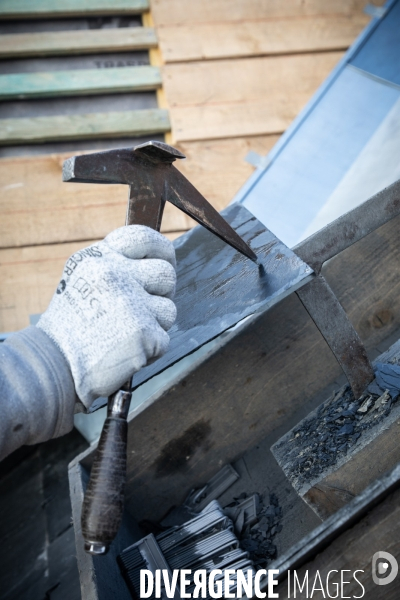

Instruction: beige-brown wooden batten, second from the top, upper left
[0,27,157,58]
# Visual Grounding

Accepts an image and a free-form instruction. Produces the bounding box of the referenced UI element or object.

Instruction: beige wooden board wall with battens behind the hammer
[0,0,383,332]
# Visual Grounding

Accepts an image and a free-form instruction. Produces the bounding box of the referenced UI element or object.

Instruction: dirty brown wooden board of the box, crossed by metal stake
[74,219,400,520]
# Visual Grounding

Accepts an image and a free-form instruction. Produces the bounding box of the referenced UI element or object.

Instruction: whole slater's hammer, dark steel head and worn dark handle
[63,141,257,555]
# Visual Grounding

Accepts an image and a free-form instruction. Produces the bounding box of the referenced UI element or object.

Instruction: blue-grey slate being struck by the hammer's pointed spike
[88,204,312,410]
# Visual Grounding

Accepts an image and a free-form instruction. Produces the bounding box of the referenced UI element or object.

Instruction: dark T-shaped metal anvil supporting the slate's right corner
[294,180,400,399]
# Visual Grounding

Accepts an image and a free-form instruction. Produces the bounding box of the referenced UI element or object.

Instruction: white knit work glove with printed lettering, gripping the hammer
[37,225,176,408]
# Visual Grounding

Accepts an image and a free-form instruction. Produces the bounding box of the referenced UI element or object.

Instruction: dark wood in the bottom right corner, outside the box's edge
[271,490,400,600]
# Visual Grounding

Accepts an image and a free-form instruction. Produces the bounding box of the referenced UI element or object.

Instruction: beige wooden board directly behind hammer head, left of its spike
[0,154,191,248]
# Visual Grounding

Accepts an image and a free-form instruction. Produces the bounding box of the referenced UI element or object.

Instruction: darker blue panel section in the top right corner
[350,1,400,85]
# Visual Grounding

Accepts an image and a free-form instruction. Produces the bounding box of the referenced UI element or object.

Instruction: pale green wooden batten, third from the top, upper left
[0,66,162,100]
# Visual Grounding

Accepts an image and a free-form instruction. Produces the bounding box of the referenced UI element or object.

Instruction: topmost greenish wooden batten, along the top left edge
[0,0,149,19]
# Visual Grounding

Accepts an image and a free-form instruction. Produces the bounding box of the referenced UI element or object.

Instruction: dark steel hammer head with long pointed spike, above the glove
[63,141,257,262]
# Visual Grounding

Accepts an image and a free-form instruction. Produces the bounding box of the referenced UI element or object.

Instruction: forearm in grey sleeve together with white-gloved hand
[0,225,176,460]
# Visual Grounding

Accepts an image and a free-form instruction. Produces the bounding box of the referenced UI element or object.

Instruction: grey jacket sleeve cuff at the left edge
[0,327,78,460]
